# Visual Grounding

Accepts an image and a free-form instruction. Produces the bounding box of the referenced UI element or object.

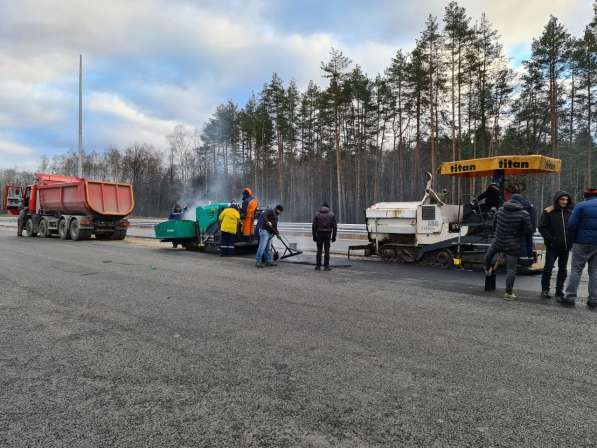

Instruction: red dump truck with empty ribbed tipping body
[2,173,135,241]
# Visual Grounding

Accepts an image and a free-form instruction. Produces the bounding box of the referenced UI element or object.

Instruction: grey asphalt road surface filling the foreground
[0,230,597,448]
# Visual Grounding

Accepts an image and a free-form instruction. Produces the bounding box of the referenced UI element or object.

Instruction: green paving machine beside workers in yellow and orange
[154,202,261,253]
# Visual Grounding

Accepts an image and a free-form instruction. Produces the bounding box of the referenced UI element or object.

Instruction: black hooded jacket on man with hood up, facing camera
[539,191,574,250]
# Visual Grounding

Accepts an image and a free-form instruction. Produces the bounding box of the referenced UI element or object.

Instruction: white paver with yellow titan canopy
[349,155,561,272]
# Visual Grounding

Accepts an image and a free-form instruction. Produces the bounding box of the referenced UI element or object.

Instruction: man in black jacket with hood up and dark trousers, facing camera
[539,191,573,299]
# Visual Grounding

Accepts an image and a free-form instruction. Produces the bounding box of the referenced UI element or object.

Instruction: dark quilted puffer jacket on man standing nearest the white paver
[494,198,533,255]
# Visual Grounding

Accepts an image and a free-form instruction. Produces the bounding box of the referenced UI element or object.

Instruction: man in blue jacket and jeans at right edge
[560,188,597,308]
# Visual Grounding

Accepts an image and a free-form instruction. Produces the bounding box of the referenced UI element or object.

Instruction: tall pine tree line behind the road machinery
[0,1,597,222]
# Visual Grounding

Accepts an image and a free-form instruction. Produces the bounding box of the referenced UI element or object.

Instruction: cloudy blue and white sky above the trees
[0,0,592,170]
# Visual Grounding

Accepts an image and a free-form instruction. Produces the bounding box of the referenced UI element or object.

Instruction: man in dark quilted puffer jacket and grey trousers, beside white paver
[485,195,532,300]
